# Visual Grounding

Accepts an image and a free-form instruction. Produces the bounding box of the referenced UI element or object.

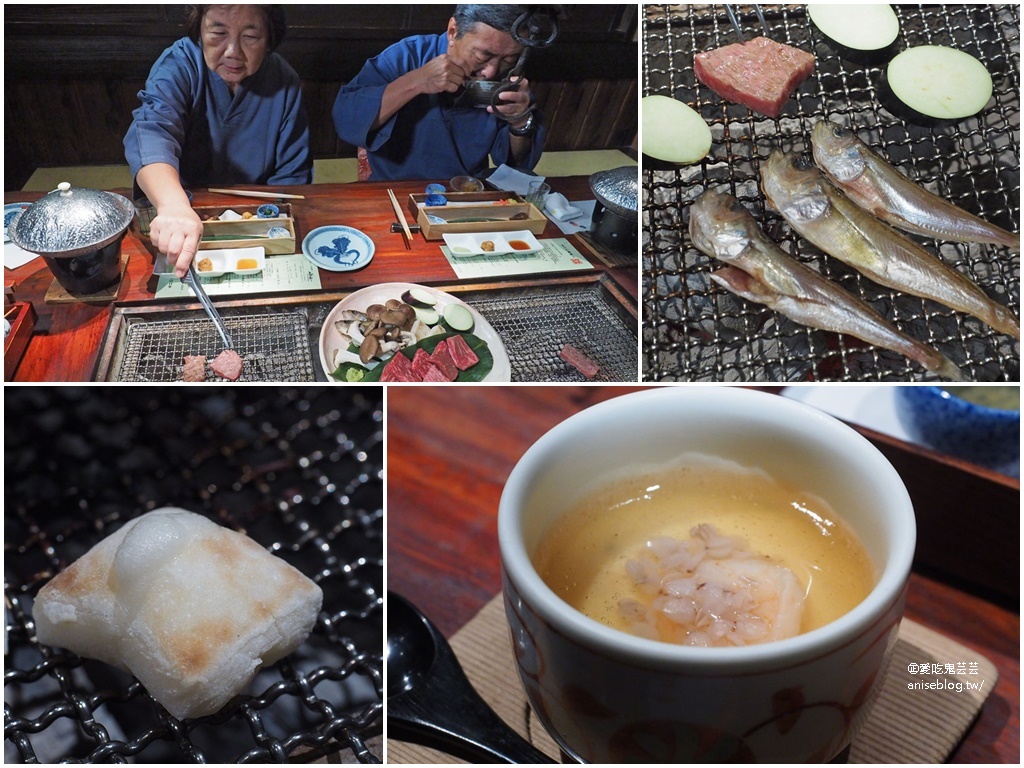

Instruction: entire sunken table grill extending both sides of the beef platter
[93,271,639,382]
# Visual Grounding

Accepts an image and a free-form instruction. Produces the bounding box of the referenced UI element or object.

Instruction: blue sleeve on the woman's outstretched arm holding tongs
[124,41,199,184]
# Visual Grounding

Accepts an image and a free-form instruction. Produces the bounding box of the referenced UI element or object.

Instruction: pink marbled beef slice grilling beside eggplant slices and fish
[693,37,814,118]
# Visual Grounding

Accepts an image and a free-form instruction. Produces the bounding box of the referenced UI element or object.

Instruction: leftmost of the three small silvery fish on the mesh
[690,189,964,381]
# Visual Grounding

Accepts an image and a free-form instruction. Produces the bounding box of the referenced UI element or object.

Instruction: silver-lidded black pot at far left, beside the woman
[7,181,135,293]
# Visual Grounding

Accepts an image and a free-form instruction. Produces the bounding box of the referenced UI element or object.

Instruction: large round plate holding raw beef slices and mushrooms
[317,283,512,381]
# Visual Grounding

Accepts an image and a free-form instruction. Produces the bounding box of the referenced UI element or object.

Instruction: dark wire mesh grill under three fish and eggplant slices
[642,4,1020,381]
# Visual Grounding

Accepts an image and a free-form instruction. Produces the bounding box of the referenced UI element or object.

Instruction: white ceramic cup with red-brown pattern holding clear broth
[498,386,916,763]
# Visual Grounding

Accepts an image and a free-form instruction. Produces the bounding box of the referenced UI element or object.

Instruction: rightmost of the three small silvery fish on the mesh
[811,120,1021,253]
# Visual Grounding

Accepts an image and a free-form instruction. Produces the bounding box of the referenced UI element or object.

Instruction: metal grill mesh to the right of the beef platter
[464,284,637,382]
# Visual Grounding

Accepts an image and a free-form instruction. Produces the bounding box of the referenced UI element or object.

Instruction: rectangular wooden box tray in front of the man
[409,191,548,240]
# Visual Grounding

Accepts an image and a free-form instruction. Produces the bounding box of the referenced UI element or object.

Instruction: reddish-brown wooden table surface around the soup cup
[386,386,1020,763]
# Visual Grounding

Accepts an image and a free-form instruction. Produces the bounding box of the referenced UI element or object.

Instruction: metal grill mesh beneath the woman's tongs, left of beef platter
[113,310,315,382]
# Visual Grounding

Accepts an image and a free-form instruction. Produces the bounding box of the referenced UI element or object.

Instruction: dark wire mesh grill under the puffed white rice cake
[4,387,384,763]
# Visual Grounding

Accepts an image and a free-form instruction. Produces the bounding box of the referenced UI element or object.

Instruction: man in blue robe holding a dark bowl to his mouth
[334,5,545,180]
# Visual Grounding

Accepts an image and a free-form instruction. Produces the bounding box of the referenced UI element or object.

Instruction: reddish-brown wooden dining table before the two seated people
[4,176,639,382]
